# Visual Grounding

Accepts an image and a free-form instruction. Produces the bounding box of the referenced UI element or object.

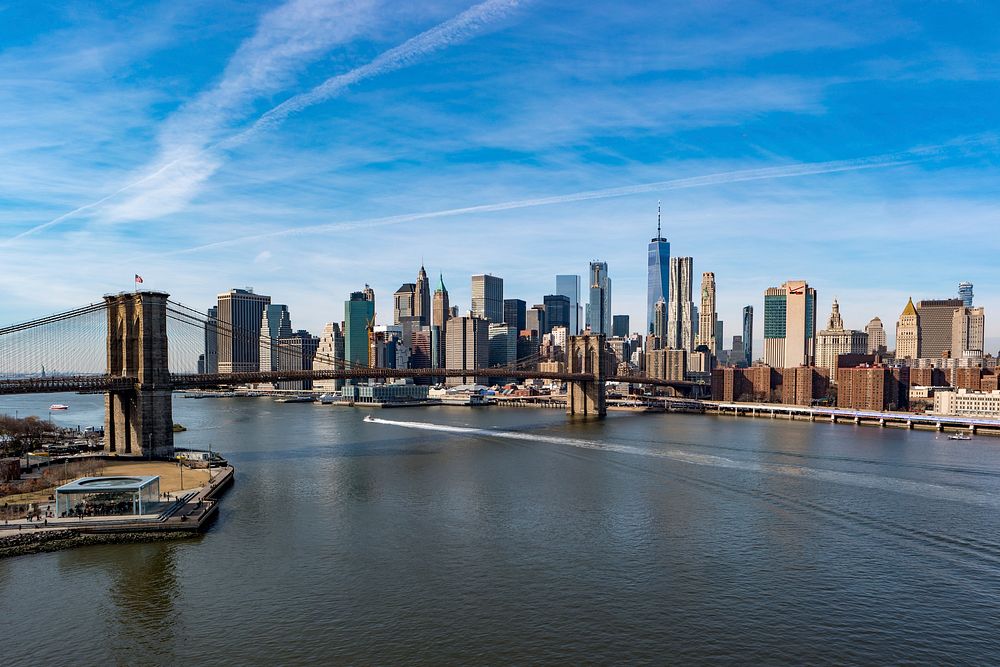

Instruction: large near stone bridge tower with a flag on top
[104,292,174,458]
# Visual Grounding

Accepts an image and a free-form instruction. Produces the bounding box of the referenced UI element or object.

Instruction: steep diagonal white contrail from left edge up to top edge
[0,0,525,247]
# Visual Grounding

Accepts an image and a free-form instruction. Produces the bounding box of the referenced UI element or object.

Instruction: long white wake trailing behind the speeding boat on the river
[365,417,1000,509]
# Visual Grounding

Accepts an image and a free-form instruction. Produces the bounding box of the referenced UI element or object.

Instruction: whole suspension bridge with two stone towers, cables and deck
[0,291,704,457]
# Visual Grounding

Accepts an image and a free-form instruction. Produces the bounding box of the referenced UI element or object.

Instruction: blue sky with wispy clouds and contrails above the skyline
[0,0,1000,353]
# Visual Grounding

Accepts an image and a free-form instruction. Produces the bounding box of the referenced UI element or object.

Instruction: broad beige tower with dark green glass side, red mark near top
[764,280,816,368]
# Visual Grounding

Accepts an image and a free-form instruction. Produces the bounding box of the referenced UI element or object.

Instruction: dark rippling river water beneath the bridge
[0,394,1000,667]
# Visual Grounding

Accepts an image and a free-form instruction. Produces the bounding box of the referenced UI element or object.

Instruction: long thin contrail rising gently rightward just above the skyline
[147,147,928,257]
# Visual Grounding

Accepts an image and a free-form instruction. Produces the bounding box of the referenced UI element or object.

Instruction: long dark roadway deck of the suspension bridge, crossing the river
[0,368,707,394]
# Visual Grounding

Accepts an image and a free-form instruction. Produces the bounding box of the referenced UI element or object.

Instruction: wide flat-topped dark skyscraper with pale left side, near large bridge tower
[216,289,271,373]
